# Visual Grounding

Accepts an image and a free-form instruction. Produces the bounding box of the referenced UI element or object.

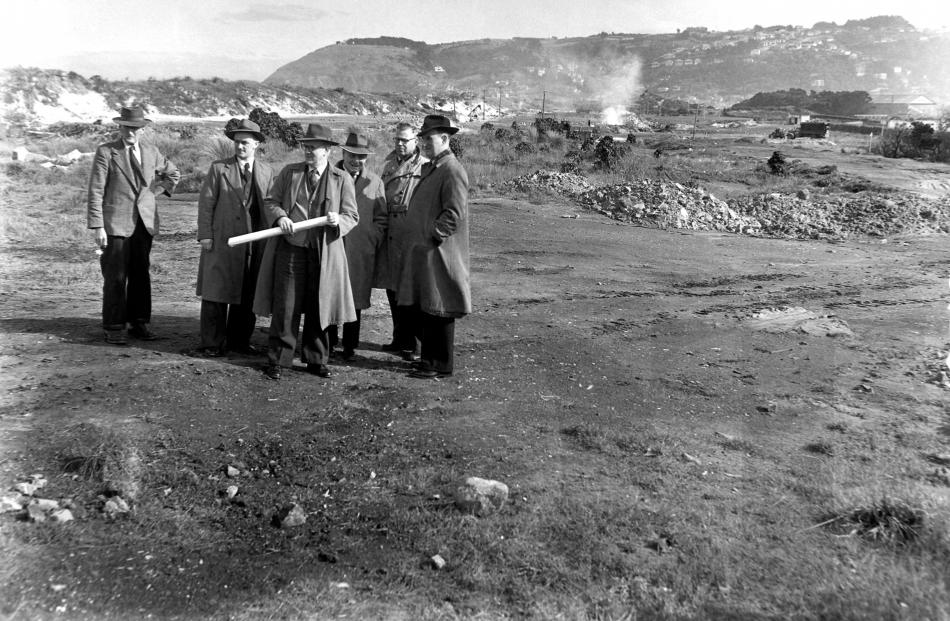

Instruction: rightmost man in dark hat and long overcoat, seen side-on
[398,114,472,379]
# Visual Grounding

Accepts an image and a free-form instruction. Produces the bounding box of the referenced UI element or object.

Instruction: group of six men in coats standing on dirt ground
[88,108,471,380]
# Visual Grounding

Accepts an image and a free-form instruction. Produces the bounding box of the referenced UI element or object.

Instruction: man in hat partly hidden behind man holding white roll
[330,132,387,360]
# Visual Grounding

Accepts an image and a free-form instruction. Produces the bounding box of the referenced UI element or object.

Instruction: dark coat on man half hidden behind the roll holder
[337,162,389,310]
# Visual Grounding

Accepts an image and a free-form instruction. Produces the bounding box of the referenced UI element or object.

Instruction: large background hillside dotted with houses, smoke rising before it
[264,17,950,108]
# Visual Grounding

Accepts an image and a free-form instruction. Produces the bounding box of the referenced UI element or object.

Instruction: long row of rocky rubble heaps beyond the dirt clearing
[503,170,950,239]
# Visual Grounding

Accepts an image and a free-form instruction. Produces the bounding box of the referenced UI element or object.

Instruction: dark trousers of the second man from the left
[199,242,261,351]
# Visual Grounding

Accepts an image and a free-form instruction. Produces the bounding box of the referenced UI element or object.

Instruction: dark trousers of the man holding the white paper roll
[267,239,330,367]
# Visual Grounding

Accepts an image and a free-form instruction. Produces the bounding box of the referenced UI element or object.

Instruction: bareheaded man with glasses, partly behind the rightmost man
[375,122,429,361]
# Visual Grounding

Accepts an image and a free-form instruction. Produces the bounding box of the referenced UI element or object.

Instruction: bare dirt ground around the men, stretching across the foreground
[0,133,950,619]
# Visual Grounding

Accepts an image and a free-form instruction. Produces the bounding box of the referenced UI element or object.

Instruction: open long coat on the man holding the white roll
[254,162,360,329]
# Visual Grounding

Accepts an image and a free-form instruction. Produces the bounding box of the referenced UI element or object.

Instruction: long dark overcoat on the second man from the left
[196,157,274,304]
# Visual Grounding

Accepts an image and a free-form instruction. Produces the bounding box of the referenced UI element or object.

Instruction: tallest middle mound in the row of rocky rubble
[578,179,761,235]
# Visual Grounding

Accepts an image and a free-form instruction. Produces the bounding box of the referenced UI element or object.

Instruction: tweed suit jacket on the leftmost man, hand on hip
[86,139,181,237]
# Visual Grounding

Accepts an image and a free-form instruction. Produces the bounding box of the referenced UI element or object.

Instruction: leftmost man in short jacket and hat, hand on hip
[86,107,181,345]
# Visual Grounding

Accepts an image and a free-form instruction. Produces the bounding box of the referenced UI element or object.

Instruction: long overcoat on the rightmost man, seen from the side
[397,150,472,317]
